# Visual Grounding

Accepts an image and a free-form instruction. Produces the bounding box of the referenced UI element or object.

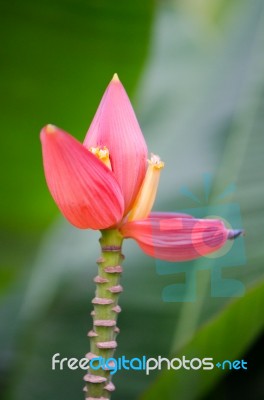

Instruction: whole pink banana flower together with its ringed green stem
[41,74,242,400]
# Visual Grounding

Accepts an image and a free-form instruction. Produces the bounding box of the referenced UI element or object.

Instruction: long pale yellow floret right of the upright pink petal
[128,154,164,221]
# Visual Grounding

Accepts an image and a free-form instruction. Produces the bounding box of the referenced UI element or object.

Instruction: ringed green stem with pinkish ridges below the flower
[84,229,124,400]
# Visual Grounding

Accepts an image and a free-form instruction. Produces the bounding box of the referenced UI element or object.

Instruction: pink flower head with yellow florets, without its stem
[41,74,242,261]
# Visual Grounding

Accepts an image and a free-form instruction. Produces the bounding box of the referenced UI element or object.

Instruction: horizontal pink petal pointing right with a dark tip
[120,213,229,261]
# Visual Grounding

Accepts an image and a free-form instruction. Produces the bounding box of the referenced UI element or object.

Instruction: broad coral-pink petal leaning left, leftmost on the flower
[41,125,124,229]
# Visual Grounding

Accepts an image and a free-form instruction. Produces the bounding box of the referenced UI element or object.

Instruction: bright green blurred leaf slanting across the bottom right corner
[140,282,264,400]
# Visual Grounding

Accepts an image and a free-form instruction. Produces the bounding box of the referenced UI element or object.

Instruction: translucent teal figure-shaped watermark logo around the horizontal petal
[155,174,246,302]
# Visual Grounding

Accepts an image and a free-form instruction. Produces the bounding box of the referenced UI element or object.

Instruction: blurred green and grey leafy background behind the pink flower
[0,0,264,400]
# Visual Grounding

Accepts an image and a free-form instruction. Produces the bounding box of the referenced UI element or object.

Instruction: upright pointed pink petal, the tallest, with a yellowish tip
[84,77,147,214]
